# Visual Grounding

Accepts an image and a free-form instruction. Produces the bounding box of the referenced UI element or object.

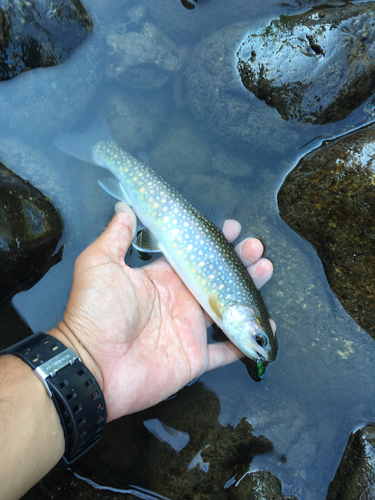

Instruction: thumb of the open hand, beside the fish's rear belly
[81,202,137,265]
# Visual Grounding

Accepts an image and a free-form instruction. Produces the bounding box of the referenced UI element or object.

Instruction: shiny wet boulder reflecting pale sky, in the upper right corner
[237,2,375,124]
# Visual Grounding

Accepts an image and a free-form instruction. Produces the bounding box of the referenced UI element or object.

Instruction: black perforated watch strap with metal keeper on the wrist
[0,332,107,465]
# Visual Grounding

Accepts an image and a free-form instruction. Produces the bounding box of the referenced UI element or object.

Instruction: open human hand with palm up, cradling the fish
[49,203,274,421]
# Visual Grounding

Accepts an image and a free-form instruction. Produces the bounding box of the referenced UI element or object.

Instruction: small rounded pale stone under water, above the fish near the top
[106,18,180,89]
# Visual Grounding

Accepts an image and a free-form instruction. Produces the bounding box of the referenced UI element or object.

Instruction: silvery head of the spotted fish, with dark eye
[222,304,278,364]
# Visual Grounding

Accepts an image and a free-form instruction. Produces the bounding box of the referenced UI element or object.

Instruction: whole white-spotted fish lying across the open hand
[54,116,278,366]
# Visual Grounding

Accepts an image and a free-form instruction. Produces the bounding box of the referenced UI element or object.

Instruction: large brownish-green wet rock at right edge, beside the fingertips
[278,125,375,339]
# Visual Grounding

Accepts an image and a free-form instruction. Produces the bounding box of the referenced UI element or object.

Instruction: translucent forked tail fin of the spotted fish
[53,115,114,164]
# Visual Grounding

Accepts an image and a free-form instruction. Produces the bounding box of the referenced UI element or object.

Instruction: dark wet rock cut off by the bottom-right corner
[327,425,375,500]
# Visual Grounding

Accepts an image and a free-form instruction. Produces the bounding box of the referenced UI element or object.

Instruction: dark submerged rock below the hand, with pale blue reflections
[73,381,282,500]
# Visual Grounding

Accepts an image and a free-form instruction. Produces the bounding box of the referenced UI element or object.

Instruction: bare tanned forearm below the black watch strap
[0,355,65,500]
